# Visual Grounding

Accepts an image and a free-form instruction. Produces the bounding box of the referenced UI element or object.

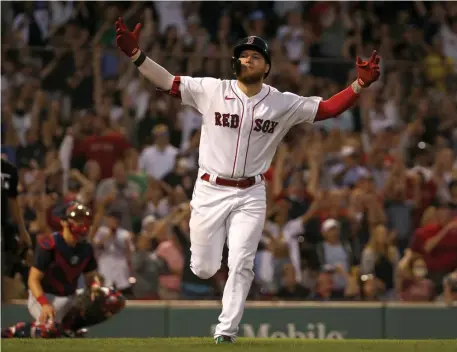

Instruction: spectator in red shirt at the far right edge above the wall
[410,205,457,292]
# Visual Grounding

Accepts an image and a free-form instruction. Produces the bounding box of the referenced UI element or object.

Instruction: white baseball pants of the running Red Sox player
[190,172,266,337]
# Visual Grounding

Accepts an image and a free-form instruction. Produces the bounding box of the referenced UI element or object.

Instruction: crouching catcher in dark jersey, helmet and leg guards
[2,203,125,338]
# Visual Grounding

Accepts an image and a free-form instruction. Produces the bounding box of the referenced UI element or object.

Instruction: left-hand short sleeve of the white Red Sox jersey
[175,76,222,114]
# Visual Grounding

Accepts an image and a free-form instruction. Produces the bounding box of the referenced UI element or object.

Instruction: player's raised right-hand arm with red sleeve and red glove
[314,51,381,121]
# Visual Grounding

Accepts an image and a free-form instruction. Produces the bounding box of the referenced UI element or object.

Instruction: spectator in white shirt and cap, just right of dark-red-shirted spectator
[140,124,178,180]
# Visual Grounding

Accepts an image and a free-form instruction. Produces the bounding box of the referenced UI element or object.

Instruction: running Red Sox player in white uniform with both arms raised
[116,18,380,343]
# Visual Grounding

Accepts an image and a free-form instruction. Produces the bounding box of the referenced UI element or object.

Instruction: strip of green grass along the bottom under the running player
[2,338,457,352]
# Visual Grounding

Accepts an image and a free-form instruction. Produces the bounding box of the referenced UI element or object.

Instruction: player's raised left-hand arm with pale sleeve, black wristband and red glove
[116,17,175,91]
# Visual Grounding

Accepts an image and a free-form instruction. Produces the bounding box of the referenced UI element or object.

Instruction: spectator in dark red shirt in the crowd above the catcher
[73,117,131,179]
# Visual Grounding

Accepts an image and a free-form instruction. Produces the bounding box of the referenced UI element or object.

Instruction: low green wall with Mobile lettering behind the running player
[1,301,457,340]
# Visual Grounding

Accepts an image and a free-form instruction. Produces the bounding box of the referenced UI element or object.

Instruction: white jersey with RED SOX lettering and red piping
[174,76,322,178]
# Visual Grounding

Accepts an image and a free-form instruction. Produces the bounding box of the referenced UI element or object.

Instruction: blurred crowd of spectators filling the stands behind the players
[1,1,457,302]
